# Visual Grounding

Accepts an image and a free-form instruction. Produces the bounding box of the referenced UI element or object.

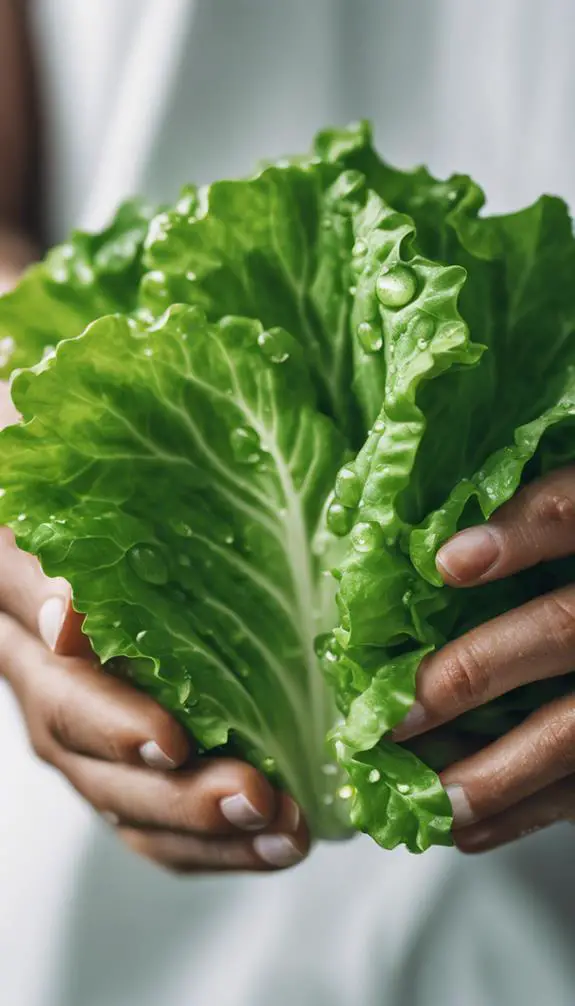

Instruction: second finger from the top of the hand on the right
[393,586,575,740]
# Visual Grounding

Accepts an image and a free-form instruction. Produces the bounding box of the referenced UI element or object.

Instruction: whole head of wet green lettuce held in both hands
[0,123,575,852]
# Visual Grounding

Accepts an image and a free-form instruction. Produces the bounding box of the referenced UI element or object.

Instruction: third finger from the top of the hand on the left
[58,755,276,836]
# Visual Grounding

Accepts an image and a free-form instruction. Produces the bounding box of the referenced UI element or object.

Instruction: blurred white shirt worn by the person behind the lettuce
[0,0,575,1006]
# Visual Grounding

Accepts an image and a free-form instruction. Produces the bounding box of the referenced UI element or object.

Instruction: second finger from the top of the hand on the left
[0,616,190,770]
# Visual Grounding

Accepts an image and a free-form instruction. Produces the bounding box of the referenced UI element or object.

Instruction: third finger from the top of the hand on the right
[441,695,575,829]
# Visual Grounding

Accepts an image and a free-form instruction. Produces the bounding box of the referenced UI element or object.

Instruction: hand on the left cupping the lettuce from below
[0,384,310,873]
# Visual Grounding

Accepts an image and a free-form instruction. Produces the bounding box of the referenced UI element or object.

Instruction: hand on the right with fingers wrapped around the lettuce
[393,468,575,852]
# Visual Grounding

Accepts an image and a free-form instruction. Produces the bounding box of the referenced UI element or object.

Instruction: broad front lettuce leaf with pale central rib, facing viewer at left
[0,306,355,834]
